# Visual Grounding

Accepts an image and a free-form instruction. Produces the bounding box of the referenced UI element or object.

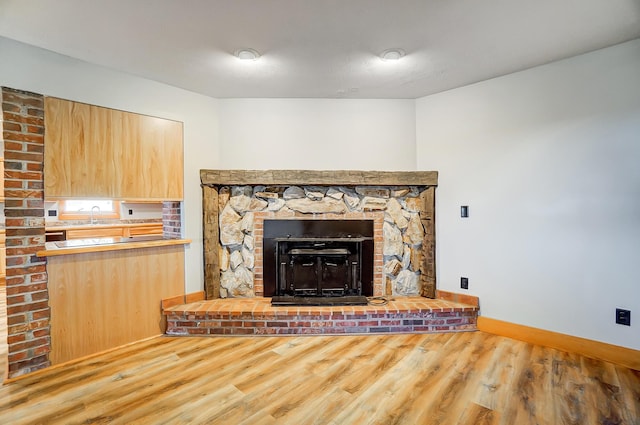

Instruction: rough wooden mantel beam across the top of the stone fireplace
[200,170,438,186]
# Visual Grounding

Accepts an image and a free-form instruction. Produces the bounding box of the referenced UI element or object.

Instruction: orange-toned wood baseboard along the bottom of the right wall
[478,316,640,370]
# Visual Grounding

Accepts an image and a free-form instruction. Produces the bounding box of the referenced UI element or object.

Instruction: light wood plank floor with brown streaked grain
[0,332,640,425]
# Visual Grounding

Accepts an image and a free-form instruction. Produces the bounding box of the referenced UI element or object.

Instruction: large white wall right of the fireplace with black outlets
[416,40,640,349]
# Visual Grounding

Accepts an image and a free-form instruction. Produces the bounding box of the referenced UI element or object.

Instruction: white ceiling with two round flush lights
[0,0,640,98]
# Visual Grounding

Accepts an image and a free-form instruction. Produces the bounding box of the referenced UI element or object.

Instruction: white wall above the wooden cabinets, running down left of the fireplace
[0,37,220,292]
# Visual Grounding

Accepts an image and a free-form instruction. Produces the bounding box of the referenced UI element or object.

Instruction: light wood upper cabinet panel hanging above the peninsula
[44,97,184,201]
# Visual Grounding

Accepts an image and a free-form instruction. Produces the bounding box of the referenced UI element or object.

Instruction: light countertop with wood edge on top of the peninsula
[36,234,191,257]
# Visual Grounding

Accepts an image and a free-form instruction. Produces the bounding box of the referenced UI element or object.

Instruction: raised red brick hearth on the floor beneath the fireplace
[163,297,479,336]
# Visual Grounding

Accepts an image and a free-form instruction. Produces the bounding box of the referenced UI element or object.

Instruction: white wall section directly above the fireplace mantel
[219,99,416,171]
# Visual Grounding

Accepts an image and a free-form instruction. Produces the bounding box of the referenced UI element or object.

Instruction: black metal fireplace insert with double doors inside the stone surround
[263,220,373,298]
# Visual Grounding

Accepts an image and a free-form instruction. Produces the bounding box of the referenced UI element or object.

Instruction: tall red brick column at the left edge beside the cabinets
[2,87,51,378]
